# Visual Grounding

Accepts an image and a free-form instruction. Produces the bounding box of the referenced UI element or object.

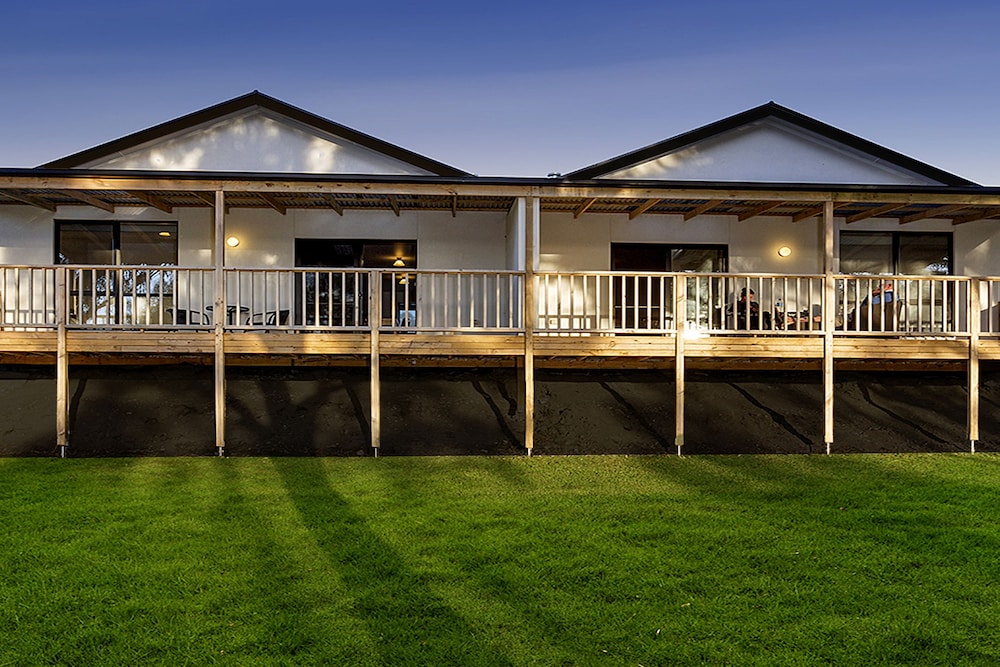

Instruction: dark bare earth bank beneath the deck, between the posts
[0,366,1000,457]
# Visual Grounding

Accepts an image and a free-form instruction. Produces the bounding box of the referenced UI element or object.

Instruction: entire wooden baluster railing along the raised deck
[0,266,988,336]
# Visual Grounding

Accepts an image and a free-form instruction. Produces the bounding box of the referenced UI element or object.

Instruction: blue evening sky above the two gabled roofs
[0,0,1000,185]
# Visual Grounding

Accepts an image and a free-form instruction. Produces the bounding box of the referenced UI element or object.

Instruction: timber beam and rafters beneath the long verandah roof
[0,170,1000,224]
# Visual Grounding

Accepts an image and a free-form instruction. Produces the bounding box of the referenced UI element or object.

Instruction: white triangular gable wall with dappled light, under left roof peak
[80,108,430,175]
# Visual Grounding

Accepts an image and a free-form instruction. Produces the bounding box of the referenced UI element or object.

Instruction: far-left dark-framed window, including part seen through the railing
[55,221,177,325]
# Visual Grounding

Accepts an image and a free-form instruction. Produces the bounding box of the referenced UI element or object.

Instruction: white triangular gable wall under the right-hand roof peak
[601,118,940,185]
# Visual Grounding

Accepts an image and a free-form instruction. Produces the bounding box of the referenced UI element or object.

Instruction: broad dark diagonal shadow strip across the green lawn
[274,459,511,665]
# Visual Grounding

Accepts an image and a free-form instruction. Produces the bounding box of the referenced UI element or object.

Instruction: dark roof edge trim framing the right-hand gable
[564,102,978,187]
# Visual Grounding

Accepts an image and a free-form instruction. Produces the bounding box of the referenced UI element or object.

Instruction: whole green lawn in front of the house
[0,455,1000,667]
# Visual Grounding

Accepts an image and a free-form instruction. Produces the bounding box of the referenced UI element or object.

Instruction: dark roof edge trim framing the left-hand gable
[39,90,472,177]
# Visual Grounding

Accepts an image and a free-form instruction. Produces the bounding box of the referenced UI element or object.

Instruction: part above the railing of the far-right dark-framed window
[840,232,953,276]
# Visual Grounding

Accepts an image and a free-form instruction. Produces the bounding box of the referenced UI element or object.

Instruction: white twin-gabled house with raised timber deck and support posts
[0,92,1000,454]
